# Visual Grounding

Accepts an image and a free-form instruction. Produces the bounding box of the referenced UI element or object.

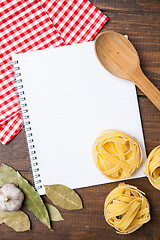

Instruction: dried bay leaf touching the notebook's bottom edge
[44,184,83,210]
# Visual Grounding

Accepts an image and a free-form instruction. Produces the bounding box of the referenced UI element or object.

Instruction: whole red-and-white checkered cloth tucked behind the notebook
[0,0,108,144]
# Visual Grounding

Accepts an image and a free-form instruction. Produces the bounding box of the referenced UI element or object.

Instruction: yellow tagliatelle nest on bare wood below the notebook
[104,183,150,234]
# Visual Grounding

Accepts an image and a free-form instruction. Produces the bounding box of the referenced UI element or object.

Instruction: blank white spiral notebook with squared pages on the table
[13,42,145,194]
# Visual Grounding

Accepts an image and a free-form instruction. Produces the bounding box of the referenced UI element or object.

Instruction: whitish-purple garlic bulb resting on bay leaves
[0,184,24,212]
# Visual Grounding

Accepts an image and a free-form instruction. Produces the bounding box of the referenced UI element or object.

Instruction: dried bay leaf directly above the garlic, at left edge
[0,163,18,187]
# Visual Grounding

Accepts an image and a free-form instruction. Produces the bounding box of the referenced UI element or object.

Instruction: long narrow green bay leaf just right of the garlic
[17,172,52,230]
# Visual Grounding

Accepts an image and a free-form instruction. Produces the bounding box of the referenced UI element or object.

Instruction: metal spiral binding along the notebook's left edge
[10,60,43,190]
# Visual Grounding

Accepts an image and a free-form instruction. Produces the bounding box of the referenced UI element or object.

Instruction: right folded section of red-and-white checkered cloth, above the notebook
[41,0,108,45]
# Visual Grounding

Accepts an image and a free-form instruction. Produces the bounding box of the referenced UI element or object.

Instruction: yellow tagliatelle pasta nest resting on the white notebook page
[92,129,142,179]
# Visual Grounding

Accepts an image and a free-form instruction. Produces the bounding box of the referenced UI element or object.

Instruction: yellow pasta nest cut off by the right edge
[146,146,160,190]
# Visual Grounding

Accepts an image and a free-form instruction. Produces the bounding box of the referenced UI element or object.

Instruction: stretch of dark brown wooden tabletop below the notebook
[0,178,160,240]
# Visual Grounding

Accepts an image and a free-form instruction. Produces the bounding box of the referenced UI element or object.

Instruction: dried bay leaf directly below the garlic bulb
[0,210,30,232]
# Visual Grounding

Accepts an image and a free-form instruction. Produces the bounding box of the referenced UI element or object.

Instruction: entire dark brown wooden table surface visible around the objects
[0,0,160,240]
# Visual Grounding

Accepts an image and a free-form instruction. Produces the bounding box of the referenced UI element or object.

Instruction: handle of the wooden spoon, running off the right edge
[130,69,160,111]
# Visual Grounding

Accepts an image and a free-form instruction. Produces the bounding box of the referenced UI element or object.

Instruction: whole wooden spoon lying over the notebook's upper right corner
[95,31,160,110]
